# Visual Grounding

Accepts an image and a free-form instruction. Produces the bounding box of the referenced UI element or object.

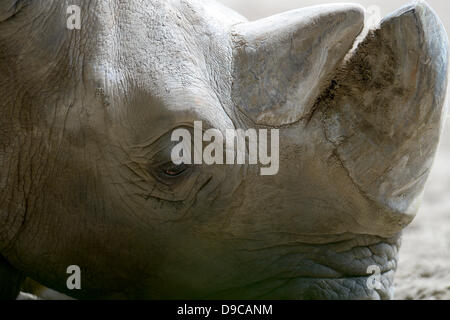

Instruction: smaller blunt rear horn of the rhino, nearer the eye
[233,4,364,126]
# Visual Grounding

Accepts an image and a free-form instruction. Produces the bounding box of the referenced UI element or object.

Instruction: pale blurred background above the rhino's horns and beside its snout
[219,0,450,299]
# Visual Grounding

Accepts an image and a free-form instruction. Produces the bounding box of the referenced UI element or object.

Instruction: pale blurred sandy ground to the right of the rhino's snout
[395,121,450,299]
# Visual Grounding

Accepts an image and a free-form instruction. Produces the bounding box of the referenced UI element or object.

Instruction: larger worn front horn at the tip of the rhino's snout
[319,2,448,222]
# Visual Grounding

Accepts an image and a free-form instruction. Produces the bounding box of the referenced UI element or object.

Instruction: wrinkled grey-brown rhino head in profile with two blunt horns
[0,0,448,299]
